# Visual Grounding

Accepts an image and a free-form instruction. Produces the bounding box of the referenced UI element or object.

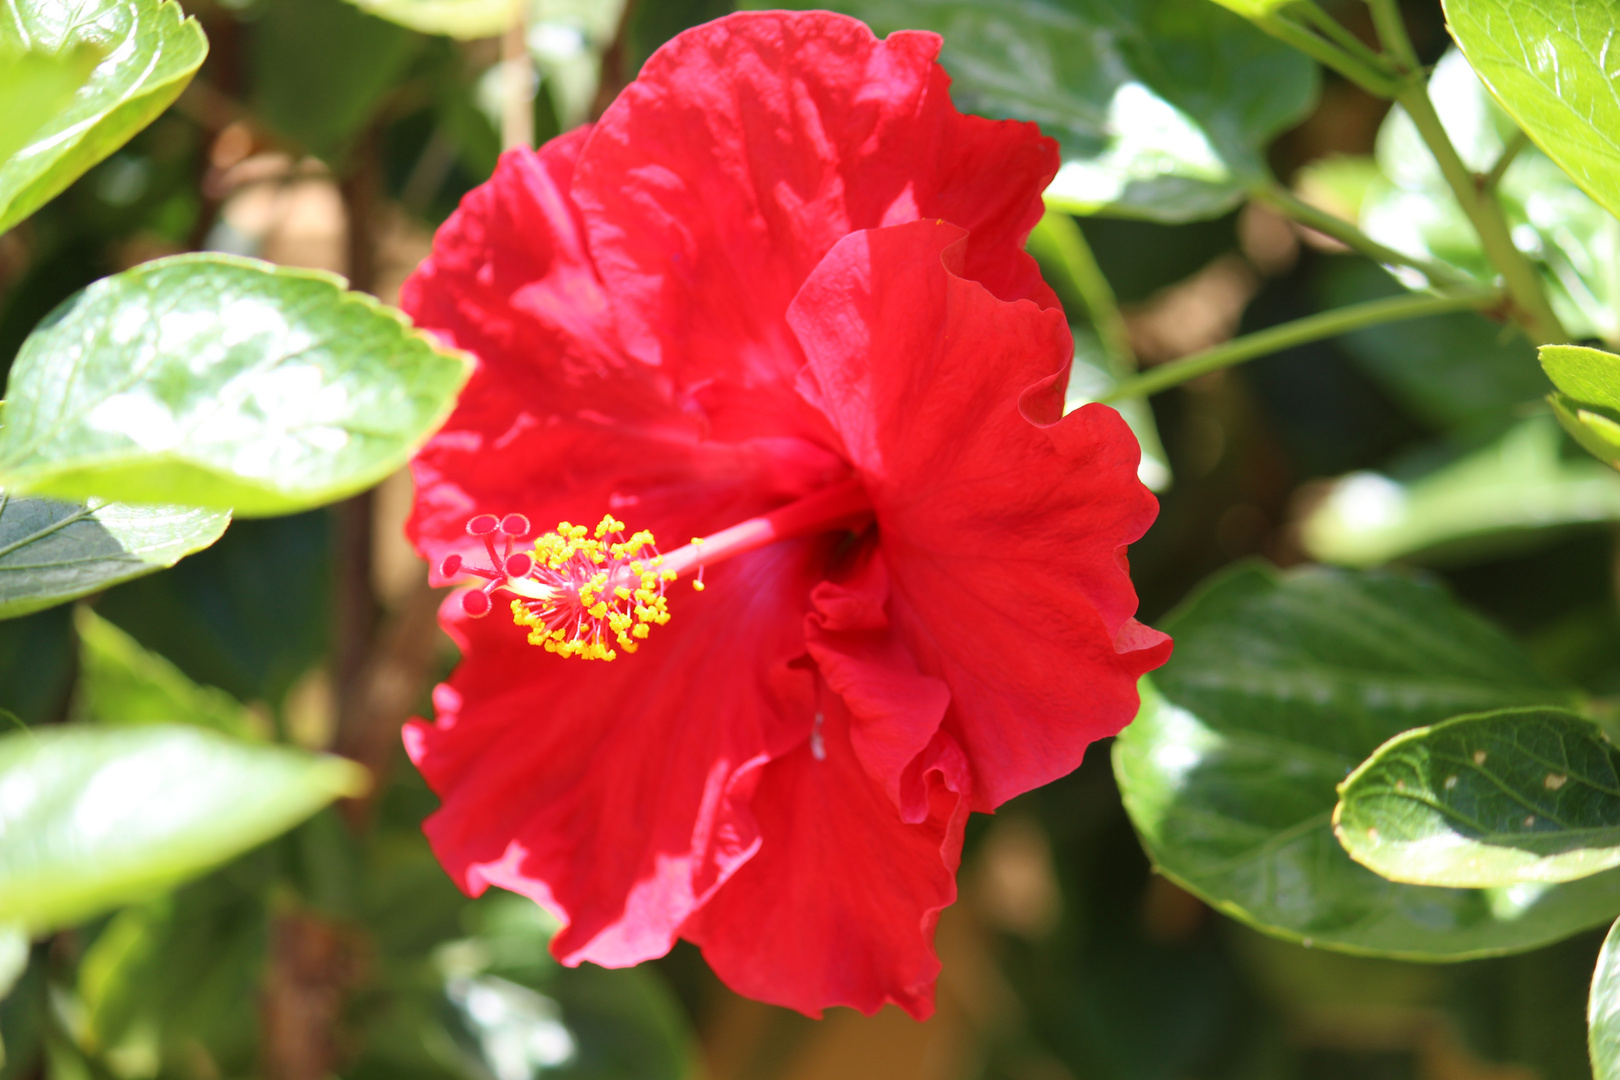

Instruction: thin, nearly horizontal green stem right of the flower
[1098,291,1502,402]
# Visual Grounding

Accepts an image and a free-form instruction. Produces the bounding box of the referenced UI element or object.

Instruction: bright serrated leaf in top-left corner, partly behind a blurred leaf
[0,0,207,233]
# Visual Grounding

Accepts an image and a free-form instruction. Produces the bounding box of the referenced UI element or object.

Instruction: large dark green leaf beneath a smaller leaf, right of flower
[1115,563,1620,960]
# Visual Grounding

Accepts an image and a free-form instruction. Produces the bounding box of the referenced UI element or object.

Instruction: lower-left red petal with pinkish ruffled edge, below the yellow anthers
[405,541,829,967]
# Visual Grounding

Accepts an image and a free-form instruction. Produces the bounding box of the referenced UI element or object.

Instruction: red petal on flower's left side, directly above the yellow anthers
[400,137,846,585]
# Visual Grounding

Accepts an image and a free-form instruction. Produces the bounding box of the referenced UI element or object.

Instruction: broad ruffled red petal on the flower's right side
[787,222,1170,810]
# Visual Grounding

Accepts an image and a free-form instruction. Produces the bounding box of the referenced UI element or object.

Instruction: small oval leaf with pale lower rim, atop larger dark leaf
[1333,709,1620,889]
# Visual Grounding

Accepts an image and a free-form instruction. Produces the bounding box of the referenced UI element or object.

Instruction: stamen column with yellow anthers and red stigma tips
[439,476,872,661]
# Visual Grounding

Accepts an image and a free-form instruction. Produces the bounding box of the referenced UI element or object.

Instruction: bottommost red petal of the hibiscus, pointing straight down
[680,695,967,1018]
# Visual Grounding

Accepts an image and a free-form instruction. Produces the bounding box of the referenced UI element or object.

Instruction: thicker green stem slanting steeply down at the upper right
[1395,83,1570,345]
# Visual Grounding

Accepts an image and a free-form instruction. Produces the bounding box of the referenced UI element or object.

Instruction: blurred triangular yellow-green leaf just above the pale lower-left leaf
[73,607,262,737]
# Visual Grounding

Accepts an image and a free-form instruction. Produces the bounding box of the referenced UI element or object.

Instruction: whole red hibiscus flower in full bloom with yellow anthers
[402,13,1170,1017]
